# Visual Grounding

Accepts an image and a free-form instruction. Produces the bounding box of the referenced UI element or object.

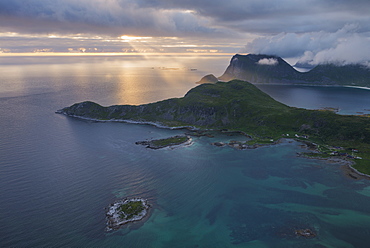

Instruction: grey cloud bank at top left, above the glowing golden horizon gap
[0,0,225,36]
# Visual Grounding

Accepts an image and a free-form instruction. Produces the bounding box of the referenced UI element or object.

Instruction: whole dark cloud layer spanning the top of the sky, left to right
[0,0,370,36]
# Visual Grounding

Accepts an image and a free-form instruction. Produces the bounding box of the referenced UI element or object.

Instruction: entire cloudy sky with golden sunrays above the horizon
[0,0,370,64]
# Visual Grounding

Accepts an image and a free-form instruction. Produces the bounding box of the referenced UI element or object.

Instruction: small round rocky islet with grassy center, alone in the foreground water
[106,198,150,231]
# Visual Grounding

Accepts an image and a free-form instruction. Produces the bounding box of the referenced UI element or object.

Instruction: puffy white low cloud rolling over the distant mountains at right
[244,24,370,65]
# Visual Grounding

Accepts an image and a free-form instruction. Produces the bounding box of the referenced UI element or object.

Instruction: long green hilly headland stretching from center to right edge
[57,80,370,174]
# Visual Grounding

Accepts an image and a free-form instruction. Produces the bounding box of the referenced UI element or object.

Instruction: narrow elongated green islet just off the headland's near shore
[135,135,192,149]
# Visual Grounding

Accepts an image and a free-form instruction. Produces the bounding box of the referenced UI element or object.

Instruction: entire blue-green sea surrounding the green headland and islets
[0,55,370,248]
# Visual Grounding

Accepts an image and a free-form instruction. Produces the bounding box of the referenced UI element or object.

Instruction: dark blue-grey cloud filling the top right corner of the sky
[134,0,370,34]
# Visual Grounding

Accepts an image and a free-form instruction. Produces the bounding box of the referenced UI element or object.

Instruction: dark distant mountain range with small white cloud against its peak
[219,54,370,87]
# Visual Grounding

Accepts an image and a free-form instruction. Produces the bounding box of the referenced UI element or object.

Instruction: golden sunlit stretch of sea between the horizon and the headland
[0,56,229,105]
